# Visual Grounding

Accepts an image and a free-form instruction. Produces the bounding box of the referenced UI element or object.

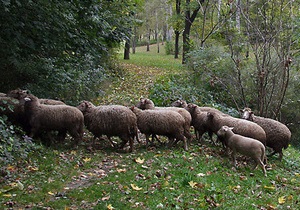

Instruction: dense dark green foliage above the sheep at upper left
[0,0,138,101]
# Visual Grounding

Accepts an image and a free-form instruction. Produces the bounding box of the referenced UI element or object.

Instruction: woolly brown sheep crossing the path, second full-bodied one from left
[77,101,138,152]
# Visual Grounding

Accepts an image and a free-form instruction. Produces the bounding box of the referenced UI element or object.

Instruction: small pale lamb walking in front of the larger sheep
[217,126,267,176]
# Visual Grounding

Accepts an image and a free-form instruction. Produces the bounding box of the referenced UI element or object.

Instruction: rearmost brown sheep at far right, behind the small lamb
[242,108,291,161]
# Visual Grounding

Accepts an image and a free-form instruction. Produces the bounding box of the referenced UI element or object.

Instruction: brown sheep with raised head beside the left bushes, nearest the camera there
[24,94,84,146]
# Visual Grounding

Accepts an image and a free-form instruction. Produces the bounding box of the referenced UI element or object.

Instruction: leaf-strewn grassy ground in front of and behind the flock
[0,44,300,209]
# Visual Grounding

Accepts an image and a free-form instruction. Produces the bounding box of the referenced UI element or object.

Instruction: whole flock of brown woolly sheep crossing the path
[0,89,291,175]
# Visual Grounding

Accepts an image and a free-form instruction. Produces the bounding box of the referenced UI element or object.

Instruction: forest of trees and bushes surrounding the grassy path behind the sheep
[0,0,300,163]
